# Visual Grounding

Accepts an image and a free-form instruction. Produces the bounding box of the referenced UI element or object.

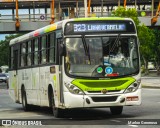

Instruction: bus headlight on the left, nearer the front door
[64,82,84,95]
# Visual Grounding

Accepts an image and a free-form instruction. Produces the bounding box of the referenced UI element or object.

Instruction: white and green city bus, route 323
[9,17,141,117]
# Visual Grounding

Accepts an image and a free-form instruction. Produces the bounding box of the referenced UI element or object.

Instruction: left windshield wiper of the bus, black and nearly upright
[82,36,91,64]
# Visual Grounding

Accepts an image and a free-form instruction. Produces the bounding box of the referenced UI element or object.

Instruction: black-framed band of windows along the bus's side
[9,29,62,70]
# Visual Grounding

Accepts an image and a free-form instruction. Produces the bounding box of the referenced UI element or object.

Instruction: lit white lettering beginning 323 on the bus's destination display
[74,24,126,32]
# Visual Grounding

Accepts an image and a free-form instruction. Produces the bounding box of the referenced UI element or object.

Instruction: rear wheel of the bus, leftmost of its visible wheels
[22,89,29,111]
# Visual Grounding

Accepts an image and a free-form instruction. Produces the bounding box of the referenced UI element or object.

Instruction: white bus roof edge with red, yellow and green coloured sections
[10,17,133,45]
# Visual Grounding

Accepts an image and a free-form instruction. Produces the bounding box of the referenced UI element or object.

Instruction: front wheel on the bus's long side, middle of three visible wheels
[51,93,62,118]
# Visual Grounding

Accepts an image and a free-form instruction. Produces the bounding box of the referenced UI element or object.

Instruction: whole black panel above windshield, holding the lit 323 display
[64,20,136,35]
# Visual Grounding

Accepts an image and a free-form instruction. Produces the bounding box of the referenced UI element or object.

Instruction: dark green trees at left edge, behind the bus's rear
[0,34,21,66]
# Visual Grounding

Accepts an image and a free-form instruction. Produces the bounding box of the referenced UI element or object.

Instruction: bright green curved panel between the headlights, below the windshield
[72,77,135,91]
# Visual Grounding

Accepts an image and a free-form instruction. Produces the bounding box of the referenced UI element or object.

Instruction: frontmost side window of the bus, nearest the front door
[49,33,56,63]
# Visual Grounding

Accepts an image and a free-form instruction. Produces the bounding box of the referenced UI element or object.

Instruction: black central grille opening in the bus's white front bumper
[91,96,118,102]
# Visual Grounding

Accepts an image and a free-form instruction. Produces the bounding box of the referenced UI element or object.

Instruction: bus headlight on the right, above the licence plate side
[124,80,141,93]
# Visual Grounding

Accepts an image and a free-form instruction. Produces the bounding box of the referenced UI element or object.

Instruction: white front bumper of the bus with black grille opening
[64,89,141,108]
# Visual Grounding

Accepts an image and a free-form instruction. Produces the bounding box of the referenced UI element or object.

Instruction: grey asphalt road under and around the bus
[0,82,160,128]
